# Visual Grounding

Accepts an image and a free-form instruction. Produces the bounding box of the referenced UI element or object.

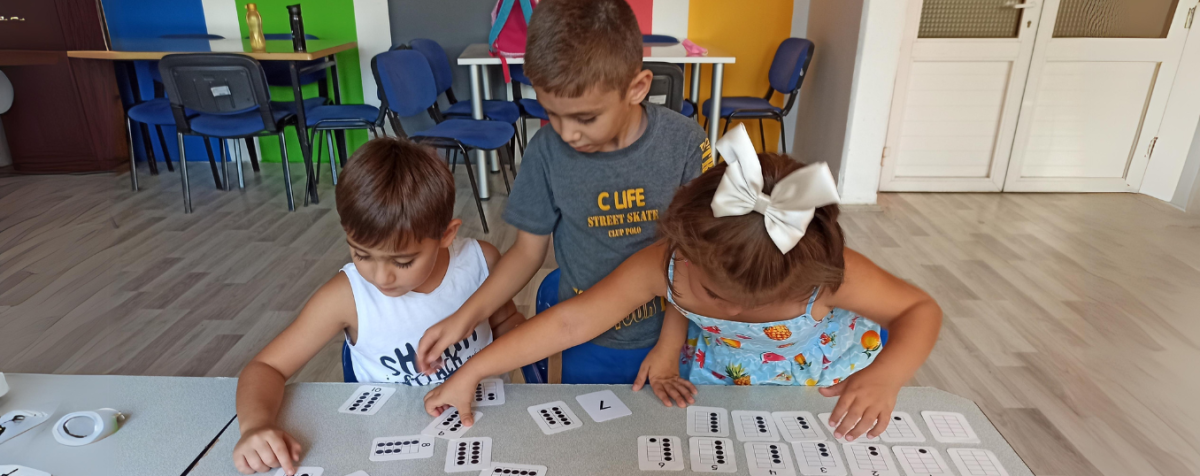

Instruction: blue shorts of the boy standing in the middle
[563,342,654,385]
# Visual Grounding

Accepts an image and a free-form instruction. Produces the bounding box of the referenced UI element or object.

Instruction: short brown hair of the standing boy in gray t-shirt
[524,0,642,97]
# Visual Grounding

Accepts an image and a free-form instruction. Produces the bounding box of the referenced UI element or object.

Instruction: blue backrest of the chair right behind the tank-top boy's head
[371,49,438,118]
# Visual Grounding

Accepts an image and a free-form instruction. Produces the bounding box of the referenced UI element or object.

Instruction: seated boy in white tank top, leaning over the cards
[233,138,524,475]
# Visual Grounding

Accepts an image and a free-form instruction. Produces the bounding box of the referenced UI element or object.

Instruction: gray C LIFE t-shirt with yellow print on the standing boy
[504,104,713,349]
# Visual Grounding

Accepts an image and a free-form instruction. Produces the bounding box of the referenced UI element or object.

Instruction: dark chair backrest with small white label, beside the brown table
[158,53,278,133]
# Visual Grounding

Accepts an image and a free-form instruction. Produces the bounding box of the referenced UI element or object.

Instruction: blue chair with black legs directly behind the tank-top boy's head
[371,49,515,233]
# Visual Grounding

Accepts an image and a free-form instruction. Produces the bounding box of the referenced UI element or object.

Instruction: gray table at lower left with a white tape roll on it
[0,374,238,476]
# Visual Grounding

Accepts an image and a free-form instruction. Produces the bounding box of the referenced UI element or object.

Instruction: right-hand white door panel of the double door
[1004,0,1196,192]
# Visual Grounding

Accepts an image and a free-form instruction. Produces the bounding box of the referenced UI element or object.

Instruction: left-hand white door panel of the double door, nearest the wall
[880,0,1042,192]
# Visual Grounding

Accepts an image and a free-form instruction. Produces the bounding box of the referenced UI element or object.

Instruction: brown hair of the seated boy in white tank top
[337,137,455,251]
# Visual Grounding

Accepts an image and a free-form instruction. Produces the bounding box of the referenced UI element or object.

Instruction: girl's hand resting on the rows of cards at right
[818,367,904,441]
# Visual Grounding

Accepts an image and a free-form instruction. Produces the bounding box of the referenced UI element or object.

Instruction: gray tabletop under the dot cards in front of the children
[188,384,1032,476]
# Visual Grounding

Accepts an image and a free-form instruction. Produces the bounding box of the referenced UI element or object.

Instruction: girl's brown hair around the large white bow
[658,153,846,305]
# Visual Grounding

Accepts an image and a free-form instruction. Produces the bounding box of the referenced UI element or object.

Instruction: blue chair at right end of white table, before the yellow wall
[700,38,814,153]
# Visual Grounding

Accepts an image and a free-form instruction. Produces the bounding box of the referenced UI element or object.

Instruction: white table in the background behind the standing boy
[458,43,737,200]
